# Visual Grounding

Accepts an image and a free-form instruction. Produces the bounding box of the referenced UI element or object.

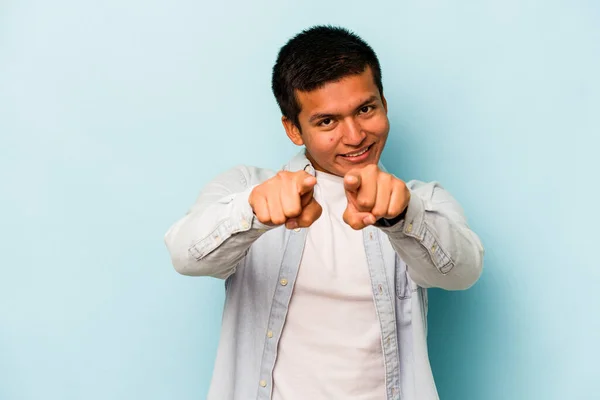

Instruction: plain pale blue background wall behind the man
[0,0,600,400]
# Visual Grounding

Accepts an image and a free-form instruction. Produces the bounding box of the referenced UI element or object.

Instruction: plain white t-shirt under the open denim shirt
[272,172,386,400]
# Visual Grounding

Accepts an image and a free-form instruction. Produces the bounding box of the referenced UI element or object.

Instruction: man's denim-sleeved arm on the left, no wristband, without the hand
[165,166,274,279]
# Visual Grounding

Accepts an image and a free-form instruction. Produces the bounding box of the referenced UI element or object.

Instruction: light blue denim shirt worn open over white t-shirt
[165,151,483,400]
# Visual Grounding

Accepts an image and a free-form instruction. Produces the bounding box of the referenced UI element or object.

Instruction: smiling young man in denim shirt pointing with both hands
[165,26,483,400]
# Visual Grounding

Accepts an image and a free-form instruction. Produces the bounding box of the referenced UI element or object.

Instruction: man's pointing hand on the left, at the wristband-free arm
[248,171,323,229]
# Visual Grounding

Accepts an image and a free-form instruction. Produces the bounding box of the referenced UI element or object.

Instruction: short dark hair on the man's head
[271,25,383,129]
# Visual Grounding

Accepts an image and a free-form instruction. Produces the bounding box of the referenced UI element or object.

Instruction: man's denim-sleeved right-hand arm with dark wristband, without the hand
[376,181,484,290]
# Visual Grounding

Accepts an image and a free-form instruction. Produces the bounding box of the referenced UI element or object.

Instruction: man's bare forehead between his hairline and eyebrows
[296,67,381,117]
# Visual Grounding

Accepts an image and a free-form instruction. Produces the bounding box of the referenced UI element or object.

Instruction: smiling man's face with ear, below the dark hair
[283,68,390,176]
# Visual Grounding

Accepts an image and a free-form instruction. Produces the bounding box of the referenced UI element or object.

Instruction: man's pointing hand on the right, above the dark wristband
[344,164,410,230]
